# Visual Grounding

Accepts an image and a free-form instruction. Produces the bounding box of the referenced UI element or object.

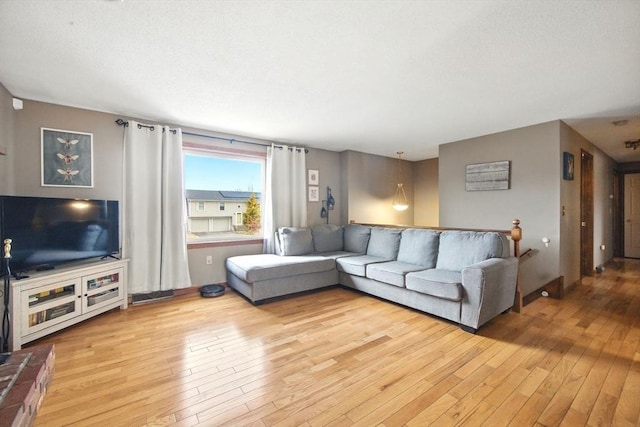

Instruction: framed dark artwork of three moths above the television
[40,128,93,188]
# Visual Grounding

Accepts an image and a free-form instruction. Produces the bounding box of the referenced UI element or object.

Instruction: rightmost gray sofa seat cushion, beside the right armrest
[405,269,462,301]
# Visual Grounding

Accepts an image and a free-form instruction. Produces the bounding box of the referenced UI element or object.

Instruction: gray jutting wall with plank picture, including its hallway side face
[439,121,616,295]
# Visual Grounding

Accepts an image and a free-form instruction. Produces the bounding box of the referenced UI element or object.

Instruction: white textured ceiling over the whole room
[0,0,640,162]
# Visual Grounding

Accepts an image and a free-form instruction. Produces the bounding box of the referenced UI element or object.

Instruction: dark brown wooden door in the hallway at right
[580,150,594,276]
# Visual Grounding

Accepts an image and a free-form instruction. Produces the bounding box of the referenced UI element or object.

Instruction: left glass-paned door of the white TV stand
[21,279,81,334]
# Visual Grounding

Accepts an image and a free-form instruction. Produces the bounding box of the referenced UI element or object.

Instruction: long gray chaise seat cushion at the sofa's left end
[225,254,335,283]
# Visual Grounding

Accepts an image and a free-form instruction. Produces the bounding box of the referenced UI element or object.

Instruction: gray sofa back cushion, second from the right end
[398,228,440,268]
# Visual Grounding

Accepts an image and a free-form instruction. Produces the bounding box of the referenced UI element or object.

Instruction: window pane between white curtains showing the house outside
[184,147,265,243]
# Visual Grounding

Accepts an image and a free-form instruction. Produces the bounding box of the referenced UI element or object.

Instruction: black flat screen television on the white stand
[0,196,120,276]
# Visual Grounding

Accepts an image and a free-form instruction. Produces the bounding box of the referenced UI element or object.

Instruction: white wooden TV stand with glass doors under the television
[9,259,129,351]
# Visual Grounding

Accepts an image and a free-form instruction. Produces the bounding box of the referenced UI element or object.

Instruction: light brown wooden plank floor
[35,260,640,426]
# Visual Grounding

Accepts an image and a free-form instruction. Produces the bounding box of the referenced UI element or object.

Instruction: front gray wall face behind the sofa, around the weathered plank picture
[439,122,561,295]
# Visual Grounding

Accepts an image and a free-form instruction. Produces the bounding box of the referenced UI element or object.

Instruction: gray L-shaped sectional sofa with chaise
[226,224,518,333]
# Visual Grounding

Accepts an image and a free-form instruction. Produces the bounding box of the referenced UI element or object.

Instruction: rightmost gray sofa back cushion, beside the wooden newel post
[436,231,509,271]
